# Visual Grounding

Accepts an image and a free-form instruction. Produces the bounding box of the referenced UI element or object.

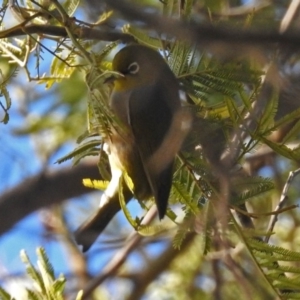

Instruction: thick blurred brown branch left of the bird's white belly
[0,163,99,235]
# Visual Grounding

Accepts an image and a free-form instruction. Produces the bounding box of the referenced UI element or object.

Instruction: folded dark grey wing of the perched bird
[129,84,176,218]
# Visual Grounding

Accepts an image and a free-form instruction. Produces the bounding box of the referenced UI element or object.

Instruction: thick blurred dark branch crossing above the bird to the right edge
[104,0,300,49]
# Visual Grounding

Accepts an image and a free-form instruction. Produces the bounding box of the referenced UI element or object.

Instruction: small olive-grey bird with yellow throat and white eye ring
[75,44,191,251]
